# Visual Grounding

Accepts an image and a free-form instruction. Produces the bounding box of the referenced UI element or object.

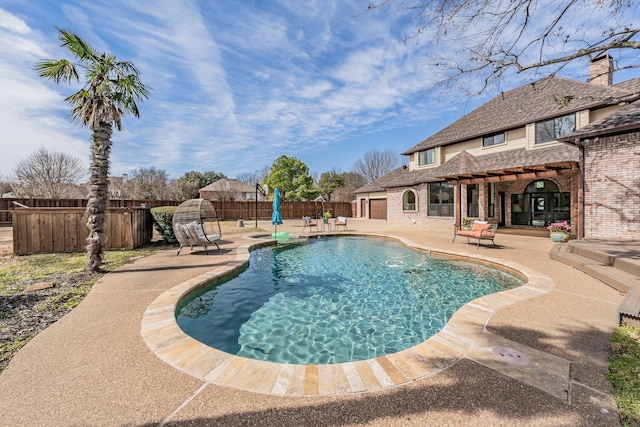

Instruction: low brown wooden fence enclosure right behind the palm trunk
[12,207,153,255]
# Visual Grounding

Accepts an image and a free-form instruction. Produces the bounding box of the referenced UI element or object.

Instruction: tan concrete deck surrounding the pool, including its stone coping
[0,219,624,426]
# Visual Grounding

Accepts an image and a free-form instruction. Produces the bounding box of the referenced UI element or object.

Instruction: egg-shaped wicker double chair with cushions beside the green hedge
[173,199,222,255]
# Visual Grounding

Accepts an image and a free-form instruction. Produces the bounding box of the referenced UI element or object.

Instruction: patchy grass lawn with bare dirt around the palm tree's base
[0,221,264,372]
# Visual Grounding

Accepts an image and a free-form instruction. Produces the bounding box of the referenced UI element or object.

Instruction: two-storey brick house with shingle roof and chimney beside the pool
[356,55,640,238]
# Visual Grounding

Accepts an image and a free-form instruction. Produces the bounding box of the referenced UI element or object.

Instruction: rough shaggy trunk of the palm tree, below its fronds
[86,122,112,272]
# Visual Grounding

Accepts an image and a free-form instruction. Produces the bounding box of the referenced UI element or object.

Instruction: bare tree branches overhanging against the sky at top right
[369,0,640,96]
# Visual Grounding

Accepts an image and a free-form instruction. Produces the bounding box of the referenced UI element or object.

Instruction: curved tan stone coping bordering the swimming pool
[140,232,555,396]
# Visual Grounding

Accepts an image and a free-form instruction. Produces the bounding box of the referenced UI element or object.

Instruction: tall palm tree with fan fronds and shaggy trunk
[35,27,149,272]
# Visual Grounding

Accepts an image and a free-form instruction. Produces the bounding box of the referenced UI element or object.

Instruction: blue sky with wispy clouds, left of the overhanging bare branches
[0,0,640,178]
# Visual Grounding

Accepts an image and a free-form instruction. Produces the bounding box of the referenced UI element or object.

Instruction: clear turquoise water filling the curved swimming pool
[177,237,522,364]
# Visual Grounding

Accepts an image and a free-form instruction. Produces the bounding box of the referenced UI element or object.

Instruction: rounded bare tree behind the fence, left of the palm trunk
[13,148,87,199]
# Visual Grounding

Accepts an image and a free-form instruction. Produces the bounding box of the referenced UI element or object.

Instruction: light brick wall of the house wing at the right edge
[584,132,640,240]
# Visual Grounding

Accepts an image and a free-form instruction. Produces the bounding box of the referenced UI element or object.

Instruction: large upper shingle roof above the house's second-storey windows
[402,77,640,155]
